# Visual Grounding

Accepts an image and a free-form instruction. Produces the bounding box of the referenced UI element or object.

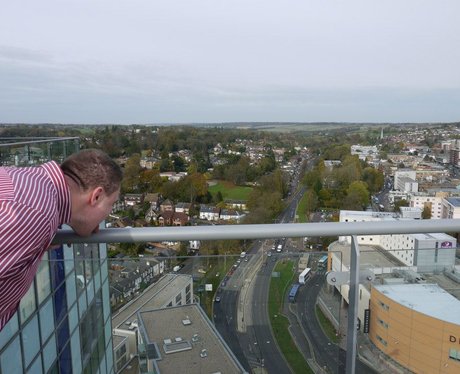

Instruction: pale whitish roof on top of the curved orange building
[373,284,460,325]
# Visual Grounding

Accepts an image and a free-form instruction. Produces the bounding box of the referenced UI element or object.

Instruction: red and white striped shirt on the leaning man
[0,161,70,330]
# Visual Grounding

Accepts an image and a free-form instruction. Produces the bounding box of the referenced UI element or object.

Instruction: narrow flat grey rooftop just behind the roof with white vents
[112,274,191,328]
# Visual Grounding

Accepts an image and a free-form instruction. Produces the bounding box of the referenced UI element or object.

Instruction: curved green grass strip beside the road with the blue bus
[268,261,313,374]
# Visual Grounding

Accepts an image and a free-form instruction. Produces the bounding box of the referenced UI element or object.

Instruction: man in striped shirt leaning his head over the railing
[0,149,122,330]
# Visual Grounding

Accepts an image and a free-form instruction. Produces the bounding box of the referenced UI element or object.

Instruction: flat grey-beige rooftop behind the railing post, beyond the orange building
[329,241,406,269]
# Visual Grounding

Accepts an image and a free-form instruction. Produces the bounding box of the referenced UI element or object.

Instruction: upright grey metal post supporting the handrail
[346,235,359,374]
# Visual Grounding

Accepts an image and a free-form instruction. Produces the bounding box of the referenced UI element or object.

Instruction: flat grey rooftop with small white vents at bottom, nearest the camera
[138,304,245,374]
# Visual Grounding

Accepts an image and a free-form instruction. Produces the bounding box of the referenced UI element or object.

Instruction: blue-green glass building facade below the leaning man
[0,139,113,374]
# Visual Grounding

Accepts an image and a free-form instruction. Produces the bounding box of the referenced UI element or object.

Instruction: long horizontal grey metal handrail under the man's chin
[53,219,460,244]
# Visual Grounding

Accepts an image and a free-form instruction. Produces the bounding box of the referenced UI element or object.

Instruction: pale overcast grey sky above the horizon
[0,0,460,124]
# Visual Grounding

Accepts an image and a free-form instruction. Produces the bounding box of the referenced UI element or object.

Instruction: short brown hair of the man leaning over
[61,149,123,195]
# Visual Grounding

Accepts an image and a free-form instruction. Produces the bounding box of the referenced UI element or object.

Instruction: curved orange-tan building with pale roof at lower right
[369,284,460,374]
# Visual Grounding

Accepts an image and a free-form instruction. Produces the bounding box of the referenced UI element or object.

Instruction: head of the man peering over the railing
[61,149,123,236]
